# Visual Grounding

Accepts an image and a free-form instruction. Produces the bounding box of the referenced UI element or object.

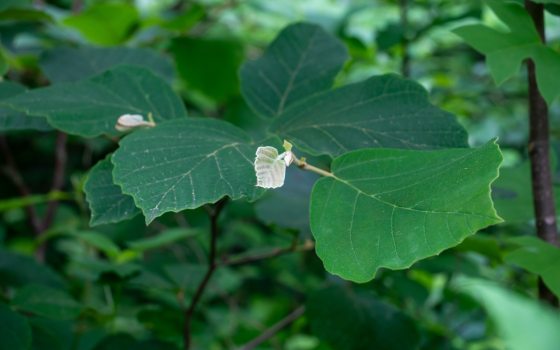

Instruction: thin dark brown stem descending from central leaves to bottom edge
[183,200,226,350]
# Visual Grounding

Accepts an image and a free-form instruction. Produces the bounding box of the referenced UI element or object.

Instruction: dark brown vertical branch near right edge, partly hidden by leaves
[525,0,558,305]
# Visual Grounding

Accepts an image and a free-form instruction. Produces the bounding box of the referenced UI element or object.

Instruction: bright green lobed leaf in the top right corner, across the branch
[454,0,560,105]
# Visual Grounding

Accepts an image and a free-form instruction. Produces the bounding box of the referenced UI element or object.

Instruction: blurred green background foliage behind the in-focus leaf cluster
[0,0,560,350]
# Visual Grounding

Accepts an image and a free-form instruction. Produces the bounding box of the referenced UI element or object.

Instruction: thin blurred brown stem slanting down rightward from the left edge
[0,136,41,234]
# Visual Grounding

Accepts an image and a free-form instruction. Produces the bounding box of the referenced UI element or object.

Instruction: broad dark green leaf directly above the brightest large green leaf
[270,75,468,156]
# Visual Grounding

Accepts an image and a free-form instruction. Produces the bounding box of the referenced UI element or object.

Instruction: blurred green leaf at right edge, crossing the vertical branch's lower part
[504,237,560,297]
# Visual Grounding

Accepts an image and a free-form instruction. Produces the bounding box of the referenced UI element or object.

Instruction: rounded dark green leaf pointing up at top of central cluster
[241,23,348,118]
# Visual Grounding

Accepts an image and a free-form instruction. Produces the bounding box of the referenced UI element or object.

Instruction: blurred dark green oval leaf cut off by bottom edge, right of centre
[306,286,420,350]
